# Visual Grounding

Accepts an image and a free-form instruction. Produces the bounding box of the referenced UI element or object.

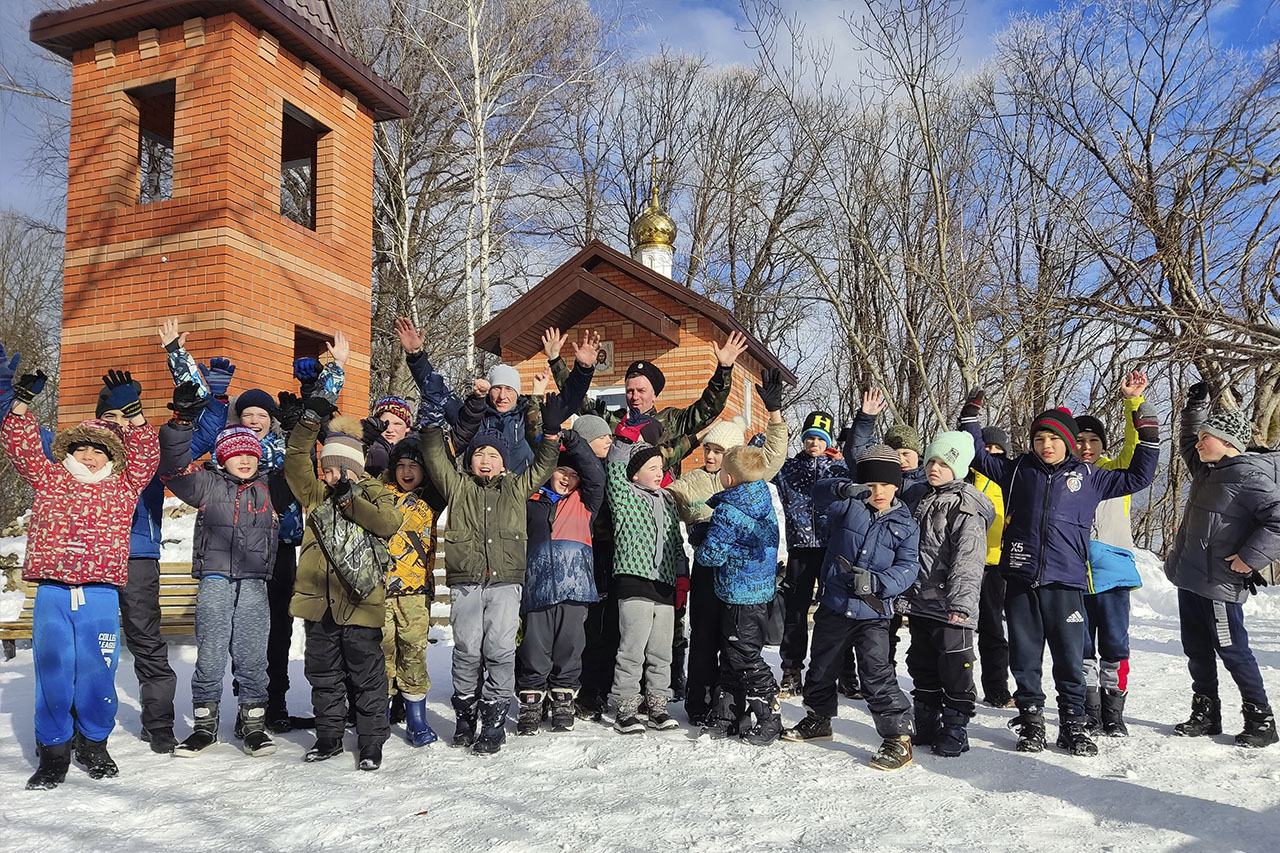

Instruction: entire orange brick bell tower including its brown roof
[31,0,408,421]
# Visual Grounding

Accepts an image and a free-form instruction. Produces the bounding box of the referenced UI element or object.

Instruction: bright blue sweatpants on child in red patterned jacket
[31,583,120,747]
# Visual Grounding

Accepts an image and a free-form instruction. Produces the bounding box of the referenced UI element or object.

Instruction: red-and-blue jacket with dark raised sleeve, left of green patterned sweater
[520,430,604,613]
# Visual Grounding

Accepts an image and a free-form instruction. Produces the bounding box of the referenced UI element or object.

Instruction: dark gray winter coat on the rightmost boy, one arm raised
[1165,407,1280,605]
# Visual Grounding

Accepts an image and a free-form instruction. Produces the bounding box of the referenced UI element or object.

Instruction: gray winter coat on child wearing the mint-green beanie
[899,480,996,628]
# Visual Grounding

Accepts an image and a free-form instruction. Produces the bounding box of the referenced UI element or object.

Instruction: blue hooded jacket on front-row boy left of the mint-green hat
[813,479,920,620]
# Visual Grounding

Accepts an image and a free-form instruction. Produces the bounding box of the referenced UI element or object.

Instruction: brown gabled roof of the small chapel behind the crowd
[475,240,796,386]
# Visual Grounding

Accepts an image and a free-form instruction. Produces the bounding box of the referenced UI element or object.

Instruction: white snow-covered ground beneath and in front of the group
[0,548,1280,853]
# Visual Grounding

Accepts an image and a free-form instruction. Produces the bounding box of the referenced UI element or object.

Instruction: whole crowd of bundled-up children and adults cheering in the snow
[0,320,1280,789]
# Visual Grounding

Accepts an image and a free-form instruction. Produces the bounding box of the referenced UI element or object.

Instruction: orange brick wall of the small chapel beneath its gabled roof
[503,256,768,471]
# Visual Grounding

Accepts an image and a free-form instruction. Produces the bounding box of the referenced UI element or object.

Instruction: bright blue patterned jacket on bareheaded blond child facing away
[694,480,778,605]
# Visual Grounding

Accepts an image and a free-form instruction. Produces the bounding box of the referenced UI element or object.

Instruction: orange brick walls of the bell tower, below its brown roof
[60,14,374,423]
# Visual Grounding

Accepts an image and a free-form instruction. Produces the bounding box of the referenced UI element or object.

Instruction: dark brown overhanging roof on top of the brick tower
[31,0,408,122]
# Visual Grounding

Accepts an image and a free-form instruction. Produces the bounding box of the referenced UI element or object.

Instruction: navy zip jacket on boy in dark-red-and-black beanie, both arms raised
[960,420,1160,589]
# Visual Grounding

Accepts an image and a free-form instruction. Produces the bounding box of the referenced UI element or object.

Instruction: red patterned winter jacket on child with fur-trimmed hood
[0,412,160,587]
